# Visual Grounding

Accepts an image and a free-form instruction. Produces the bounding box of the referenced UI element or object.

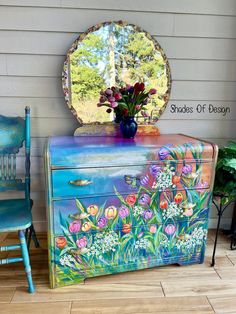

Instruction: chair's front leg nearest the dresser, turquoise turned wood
[18,230,35,293]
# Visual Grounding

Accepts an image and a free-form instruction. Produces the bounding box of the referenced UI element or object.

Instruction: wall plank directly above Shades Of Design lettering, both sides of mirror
[0,76,236,101]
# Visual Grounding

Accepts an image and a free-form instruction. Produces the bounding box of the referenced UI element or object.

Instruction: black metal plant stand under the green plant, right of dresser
[211,194,236,267]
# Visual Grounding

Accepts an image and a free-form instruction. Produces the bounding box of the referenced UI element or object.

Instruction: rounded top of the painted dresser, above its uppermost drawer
[47,134,218,168]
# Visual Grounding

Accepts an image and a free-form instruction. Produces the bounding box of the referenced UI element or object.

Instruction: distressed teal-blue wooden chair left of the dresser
[0,107,35,293]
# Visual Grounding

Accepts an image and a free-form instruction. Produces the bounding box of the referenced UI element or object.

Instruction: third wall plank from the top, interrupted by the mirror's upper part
[0,32,236,60]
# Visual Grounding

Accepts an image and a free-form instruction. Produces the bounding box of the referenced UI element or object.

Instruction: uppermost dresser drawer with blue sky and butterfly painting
[52,161,212,198]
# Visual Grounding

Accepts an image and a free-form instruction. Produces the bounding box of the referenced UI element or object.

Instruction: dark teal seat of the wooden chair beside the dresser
[0,199,32,232]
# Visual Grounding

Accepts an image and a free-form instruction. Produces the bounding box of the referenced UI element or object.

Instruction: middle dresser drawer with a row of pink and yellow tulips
[53,186,211,236]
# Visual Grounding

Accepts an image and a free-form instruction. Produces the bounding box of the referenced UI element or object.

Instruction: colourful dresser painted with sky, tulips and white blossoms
[45,135,217,288]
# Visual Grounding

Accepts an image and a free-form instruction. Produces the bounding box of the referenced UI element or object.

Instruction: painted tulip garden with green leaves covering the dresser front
[51,142,212,286]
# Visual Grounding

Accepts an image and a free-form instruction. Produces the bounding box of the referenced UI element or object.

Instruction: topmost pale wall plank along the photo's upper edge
[0,0,236,15]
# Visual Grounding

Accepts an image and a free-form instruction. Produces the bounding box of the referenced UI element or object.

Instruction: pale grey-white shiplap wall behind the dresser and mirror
[0,0,236,229]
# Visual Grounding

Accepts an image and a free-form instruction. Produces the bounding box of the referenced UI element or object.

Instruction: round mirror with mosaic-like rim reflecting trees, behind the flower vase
[62,21,171,124]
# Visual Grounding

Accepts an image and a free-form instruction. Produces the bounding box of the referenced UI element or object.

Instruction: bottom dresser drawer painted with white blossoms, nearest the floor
[53,213,207,286]
